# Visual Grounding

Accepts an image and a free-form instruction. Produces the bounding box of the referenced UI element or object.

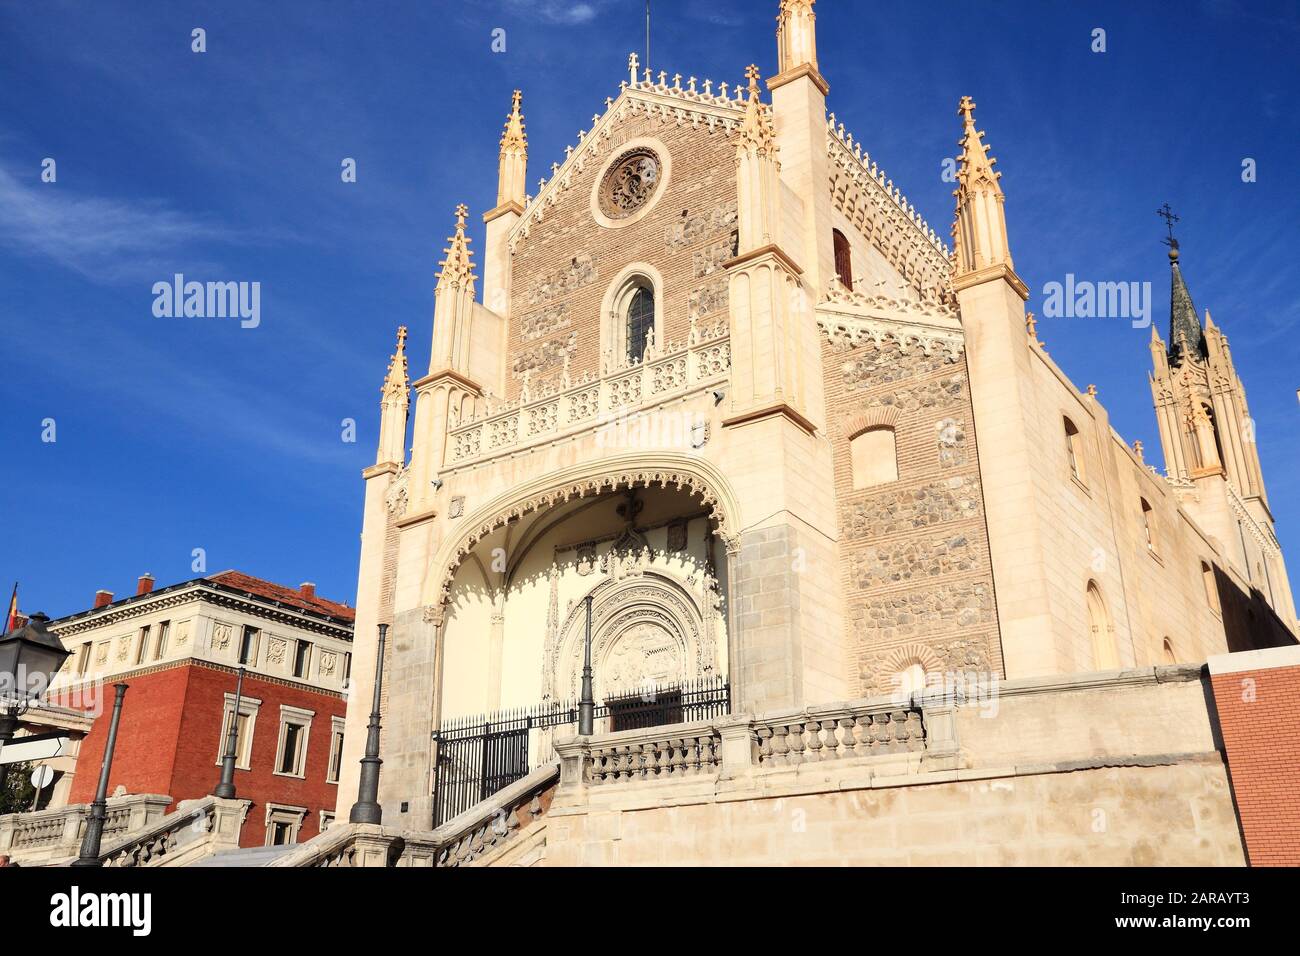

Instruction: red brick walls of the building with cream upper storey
[55,662,346,847]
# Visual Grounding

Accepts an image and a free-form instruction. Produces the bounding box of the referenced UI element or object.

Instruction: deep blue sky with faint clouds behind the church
[0,0,1300,615]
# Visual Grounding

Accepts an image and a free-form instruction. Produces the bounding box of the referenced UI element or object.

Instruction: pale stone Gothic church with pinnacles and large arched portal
[339,0,1296,829]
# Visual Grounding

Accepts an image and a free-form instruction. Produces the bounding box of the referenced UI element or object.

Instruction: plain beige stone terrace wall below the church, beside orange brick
[533,667,1244,866]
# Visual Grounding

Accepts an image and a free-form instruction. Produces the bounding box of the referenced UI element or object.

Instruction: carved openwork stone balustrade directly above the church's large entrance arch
[447,321,731,467]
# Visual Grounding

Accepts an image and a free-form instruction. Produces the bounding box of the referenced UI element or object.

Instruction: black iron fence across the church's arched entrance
[433,676,731,827]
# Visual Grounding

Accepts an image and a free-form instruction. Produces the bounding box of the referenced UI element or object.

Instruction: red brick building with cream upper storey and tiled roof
[49,571,354,847]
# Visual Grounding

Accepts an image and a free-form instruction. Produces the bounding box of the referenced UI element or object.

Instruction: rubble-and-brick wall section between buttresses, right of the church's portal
[823,338,1002,693]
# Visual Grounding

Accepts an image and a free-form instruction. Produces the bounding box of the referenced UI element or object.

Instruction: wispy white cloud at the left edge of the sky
[0,168,244,282]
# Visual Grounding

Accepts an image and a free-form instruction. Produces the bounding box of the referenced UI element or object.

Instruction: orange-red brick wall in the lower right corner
[1212,667,1300,866]
